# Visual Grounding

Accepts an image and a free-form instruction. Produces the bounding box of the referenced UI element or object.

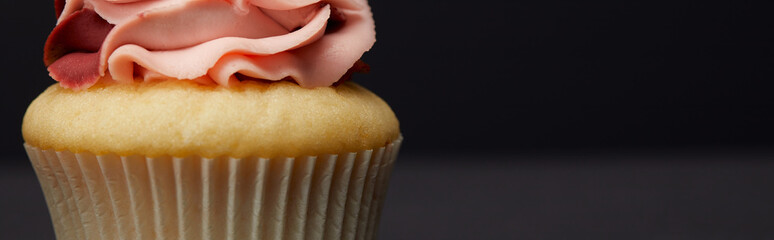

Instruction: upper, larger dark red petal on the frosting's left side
[43,9,113,66]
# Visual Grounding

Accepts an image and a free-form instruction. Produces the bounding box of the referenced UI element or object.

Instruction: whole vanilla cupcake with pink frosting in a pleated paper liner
[22,0,402,240]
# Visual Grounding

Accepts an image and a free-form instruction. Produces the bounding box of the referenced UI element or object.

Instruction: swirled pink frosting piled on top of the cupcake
[47,0,375,89]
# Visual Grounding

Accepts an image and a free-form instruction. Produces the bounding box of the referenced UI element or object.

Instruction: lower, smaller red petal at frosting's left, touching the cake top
[48,51,100,90]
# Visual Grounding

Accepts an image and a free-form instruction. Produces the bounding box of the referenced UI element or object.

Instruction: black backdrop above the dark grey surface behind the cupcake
[0,0,774,158]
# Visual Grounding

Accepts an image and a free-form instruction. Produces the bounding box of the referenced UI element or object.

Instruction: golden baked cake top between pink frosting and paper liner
[22,81,400,158]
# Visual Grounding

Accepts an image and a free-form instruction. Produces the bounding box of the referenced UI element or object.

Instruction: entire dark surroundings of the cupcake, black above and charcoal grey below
[0,0,774,239]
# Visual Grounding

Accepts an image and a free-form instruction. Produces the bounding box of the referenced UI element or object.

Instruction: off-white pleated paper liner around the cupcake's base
[25,139,402,240]
